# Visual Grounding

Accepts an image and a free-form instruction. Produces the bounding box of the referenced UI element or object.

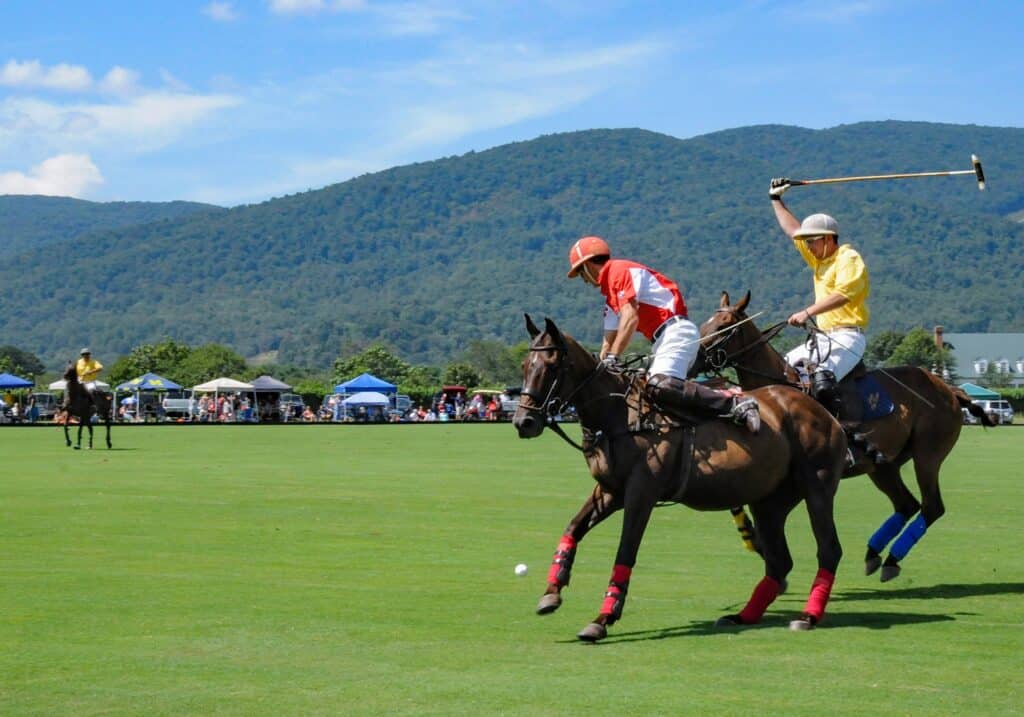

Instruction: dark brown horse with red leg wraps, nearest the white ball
[512,315,847,642]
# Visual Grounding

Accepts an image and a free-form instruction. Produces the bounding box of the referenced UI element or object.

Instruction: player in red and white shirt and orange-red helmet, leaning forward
[568,237,761,433]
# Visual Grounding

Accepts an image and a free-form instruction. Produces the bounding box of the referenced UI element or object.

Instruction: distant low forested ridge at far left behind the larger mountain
[0,195,223,258]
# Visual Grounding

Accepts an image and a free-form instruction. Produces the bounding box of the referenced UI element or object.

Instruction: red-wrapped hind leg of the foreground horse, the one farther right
[790,466,843,630]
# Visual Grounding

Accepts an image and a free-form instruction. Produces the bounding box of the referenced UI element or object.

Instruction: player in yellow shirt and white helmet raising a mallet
[768,178,870,414]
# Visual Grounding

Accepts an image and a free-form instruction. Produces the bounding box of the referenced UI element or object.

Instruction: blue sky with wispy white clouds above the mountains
[0,0,1024,206]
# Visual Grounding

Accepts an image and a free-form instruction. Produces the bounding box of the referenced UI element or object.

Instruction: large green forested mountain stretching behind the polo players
[0,122,1024,366]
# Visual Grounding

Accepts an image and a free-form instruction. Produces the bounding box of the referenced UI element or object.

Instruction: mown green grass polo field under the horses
[0,424,1024,717]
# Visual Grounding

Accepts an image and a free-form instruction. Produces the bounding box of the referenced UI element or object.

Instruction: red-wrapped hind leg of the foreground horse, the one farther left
[715,491,800,627]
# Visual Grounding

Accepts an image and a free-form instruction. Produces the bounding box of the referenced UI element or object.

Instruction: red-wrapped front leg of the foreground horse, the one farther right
[577,489,656,642]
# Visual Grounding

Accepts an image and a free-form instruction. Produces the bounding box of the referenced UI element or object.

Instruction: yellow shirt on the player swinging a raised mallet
[793,239,871,331]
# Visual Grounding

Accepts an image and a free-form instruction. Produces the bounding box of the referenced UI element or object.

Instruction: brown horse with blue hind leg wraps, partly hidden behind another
[691,291,993,582]
